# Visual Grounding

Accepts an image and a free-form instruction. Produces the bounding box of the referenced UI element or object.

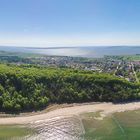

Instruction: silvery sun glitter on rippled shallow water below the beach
[24,116,84,140]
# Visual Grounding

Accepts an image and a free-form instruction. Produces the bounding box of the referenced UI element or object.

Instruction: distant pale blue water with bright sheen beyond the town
[0,46,140,58]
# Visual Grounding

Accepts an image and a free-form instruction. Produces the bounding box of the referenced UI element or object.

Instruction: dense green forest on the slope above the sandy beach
[0,64,140,112]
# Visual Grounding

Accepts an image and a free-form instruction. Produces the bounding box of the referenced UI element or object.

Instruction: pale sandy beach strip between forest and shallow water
[0,101,140,125]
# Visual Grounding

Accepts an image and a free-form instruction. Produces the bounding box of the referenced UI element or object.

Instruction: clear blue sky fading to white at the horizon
[0,0,140,47]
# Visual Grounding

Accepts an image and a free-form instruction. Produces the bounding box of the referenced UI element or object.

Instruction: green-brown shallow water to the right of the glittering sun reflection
[81,111,140,140]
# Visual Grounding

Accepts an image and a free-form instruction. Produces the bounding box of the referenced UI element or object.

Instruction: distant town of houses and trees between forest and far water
[0,51,140,83]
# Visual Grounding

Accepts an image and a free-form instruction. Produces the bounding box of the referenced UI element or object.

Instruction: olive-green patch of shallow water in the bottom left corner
[0,125,33,140]
